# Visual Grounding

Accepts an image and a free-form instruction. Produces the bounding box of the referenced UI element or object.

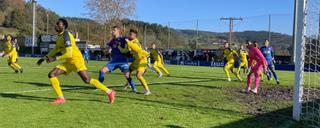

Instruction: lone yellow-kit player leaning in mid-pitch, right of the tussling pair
[150,43,170,77]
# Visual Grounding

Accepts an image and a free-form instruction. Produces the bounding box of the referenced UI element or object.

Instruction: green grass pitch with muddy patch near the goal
[0,58,306,128]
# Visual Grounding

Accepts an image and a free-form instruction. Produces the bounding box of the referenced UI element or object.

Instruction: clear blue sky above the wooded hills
[38,0,294,34]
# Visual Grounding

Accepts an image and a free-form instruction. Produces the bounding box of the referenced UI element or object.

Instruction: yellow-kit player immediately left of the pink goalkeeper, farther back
[237,44,248,75]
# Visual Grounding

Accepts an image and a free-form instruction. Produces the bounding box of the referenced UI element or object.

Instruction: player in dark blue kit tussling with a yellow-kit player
[99,26,137,92]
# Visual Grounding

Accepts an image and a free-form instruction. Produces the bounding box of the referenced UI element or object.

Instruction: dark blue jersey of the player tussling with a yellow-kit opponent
[107,37,128,63]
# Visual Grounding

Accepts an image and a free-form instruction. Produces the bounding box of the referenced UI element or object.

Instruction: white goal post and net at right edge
[293,0,320,128]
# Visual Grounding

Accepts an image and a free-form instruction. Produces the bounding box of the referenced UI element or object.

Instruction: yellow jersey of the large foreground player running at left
[47,31,83,64]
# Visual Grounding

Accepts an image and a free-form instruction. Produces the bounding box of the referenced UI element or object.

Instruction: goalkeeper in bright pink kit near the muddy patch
[247,44,268,94]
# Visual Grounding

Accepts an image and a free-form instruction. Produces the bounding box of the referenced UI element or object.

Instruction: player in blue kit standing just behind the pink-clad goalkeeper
[260,40,280,84]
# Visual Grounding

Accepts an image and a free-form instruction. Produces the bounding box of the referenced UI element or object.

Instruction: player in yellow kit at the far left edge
[2,34,23,73]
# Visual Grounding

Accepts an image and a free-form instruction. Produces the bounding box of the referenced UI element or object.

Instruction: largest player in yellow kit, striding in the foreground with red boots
[37,19,116,104]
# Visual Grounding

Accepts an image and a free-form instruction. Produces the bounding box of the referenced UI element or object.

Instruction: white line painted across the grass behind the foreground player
[0,79,220,94]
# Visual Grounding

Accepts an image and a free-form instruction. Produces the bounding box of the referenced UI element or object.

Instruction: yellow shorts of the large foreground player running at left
[56,61,87,75]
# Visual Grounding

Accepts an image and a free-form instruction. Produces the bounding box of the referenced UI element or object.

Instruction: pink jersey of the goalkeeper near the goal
[249,47,267,66]
